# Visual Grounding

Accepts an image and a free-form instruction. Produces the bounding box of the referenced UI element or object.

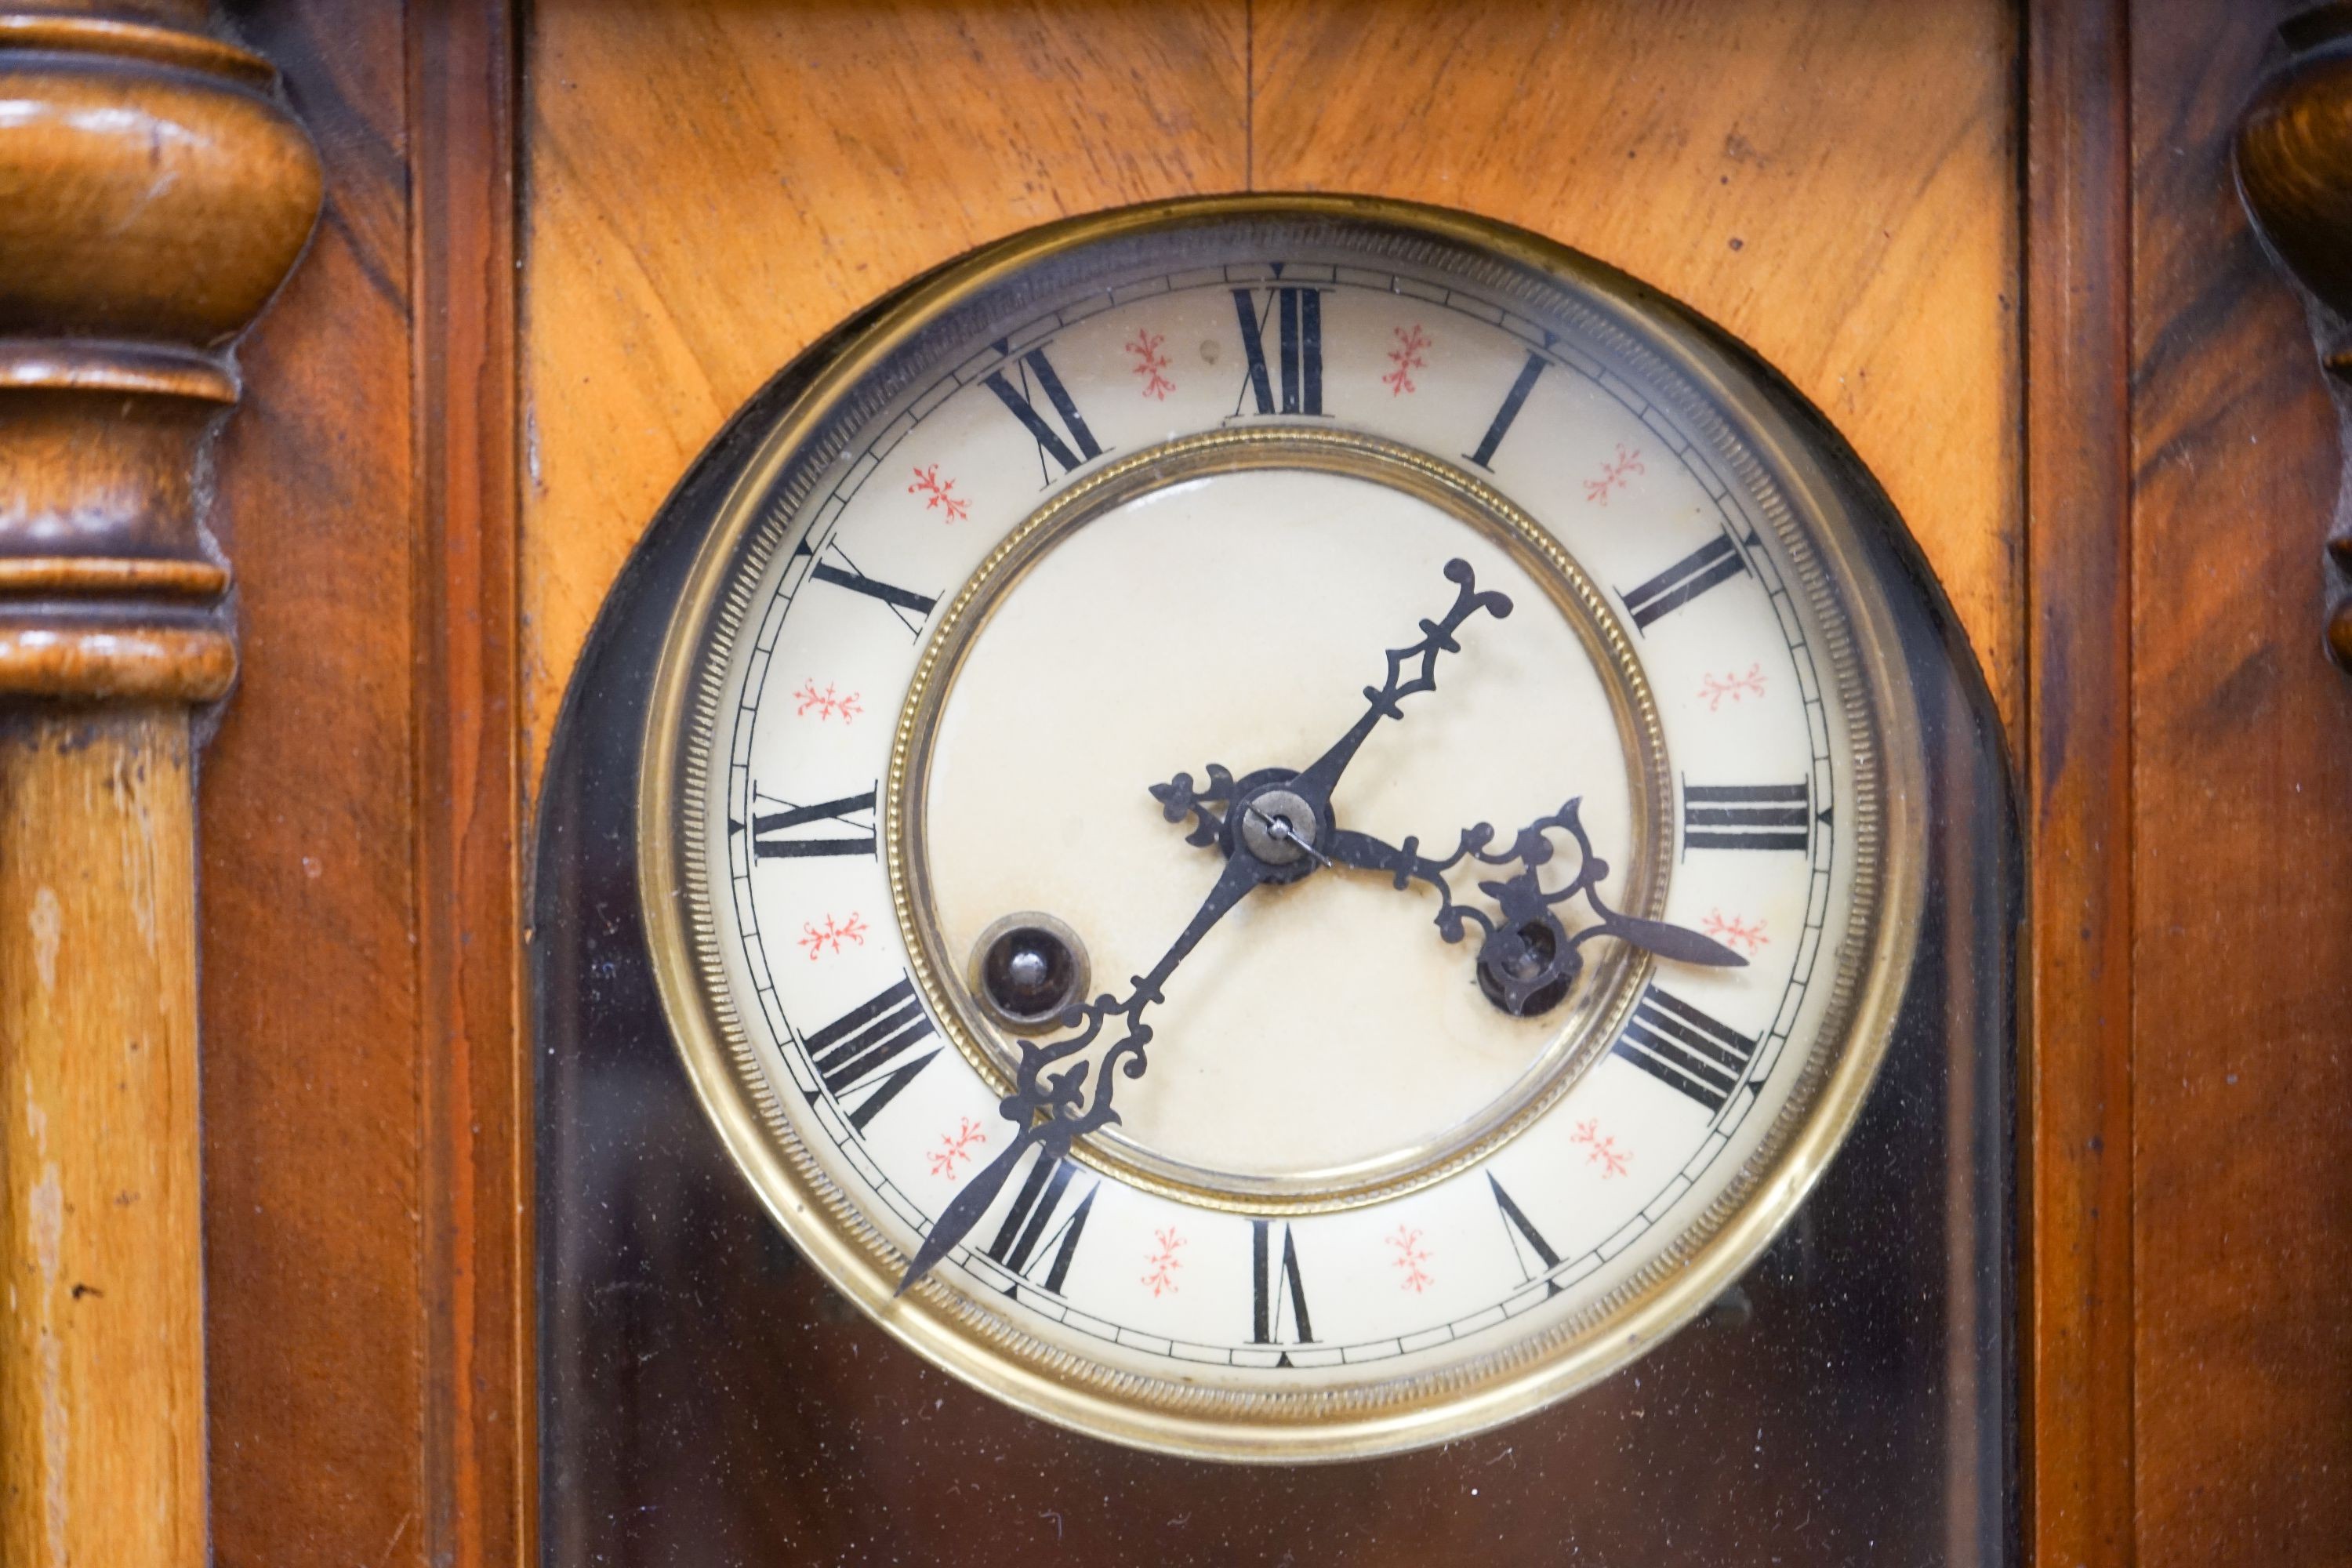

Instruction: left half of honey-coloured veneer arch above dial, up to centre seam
[522,0,1247,776]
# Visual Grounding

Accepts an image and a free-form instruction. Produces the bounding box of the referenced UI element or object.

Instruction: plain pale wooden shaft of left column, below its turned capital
[0,719,205,1568]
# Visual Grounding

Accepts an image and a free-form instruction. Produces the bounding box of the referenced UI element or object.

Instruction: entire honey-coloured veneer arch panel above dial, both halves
[522,0,2023,776]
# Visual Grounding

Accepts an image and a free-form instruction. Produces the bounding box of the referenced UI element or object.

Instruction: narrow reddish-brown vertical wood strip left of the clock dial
[407,0,532,1568]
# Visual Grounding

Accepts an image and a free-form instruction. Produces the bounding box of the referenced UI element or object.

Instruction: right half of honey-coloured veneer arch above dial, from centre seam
[1249,0,2023,738]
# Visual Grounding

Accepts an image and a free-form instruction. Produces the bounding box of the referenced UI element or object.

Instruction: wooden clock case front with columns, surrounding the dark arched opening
[0,0,2352,1566]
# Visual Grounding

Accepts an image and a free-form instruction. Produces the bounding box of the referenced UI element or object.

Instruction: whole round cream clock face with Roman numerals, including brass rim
[644,200,1915,1460]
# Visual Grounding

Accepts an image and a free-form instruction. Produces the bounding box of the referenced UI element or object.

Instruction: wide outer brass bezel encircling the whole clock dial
[637,195,1926,1462]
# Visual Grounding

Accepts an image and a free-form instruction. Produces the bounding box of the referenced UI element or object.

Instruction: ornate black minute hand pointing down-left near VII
[898,851,1277,1295]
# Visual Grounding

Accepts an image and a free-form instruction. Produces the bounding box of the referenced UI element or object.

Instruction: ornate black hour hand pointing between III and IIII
[1322,799,1748,1018]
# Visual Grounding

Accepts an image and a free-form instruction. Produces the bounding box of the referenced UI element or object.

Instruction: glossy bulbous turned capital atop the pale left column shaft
[0,0,320,701]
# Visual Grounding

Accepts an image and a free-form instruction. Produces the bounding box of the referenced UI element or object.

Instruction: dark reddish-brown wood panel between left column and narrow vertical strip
[200,0,428,1568]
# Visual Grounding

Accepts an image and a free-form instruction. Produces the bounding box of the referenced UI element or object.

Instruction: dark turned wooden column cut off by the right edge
[2237,0,2352,670]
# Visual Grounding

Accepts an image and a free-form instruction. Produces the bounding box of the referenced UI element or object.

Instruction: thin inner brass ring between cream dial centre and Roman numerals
[880,426,1675,1215]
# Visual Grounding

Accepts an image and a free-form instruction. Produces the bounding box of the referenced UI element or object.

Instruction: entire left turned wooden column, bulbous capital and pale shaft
[0,0,320,1568]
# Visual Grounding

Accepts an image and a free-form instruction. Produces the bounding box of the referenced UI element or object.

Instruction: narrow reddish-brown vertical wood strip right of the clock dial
[2020,0,2133,1566]
